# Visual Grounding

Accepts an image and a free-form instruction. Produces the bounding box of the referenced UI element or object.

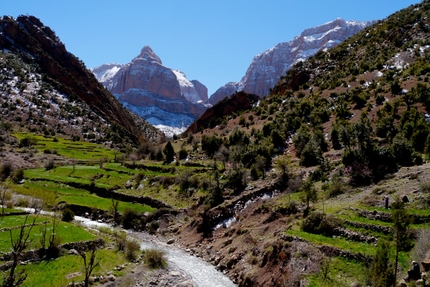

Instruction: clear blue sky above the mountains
[0,0,421,96]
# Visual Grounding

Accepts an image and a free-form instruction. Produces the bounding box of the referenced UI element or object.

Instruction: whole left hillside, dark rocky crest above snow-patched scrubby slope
[0,16,163,146]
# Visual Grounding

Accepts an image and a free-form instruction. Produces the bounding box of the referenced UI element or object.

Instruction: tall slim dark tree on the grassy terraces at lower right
[391,198,412,286]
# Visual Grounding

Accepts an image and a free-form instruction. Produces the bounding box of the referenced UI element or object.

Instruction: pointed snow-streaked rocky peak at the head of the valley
[91,46,208,133]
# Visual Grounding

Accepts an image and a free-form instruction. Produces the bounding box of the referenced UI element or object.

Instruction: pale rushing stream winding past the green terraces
[20,212,236,287]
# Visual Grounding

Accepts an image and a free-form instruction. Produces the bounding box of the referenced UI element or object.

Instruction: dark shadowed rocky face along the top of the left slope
[0,16,164,144]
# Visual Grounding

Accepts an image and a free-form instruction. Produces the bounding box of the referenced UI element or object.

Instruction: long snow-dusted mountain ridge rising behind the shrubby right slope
[209,18,373,105]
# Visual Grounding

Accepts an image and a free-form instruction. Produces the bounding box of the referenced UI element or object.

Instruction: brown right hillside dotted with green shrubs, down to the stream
[170,1,430,286]
